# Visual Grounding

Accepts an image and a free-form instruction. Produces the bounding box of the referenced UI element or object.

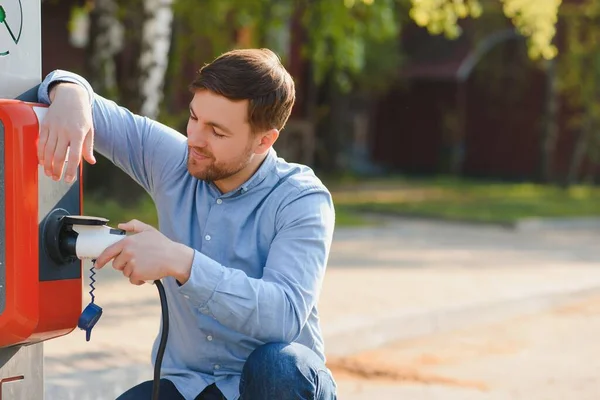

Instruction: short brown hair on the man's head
[190,49,296,133]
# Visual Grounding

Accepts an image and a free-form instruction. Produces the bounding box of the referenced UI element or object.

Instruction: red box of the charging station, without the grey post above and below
[0,99,82,348]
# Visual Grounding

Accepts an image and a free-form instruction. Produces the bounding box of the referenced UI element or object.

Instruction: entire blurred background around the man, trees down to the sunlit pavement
[37,0,600,400]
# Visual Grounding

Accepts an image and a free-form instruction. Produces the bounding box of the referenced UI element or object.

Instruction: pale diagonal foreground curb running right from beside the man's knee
[324,282,600,357]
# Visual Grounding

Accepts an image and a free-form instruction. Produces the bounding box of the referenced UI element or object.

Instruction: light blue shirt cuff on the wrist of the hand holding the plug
[179,250,225,313]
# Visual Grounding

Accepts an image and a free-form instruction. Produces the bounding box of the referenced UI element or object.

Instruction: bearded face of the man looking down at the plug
[187,90,255,182]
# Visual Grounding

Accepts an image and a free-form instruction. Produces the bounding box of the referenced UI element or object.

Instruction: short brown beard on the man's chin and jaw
[187,144,252,182]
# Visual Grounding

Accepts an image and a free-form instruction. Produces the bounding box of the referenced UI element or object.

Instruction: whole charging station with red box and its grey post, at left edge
[0,0,88,400]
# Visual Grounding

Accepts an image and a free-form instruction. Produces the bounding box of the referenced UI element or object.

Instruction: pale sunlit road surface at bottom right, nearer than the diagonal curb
[330,297,600,400]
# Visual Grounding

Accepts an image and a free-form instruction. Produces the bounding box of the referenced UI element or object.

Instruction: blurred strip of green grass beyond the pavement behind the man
[84,177,600,227]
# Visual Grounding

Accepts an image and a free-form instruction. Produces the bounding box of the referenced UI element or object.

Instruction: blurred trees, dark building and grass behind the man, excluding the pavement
[42,0,600,224]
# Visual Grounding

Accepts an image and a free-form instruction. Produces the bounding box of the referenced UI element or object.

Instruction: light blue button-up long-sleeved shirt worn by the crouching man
[38,70,335,400]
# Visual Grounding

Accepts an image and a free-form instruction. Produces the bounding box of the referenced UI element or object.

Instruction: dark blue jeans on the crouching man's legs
[117,343,337,400]
